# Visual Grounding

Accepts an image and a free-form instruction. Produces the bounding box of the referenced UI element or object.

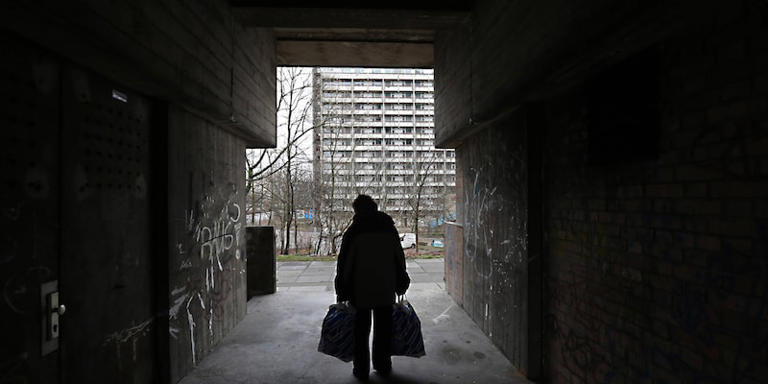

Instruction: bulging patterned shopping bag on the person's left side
[317,303,355,362]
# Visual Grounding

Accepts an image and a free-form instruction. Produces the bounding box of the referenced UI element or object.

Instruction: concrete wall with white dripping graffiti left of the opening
[168,108,246,382]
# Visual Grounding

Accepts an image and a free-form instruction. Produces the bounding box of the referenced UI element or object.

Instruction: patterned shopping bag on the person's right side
[391,296,426,357]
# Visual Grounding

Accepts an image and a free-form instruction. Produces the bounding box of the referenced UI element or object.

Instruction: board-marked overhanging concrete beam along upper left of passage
[0,2,276,147]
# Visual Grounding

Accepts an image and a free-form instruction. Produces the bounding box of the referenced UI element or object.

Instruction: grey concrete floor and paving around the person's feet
[180,260,529,384]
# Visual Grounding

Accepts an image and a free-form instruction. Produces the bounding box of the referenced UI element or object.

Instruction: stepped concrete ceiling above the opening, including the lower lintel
[232,1,473,68]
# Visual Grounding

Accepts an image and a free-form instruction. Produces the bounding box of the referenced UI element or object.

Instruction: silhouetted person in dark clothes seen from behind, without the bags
[335,195,411,380]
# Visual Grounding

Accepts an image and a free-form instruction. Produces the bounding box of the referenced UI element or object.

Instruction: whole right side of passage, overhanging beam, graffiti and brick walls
[435,0,768,382]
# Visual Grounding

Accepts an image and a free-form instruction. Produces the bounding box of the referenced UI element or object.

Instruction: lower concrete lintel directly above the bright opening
[276,41,434,68]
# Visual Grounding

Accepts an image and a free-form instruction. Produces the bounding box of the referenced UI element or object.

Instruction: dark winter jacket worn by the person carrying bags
[335,211,411,308]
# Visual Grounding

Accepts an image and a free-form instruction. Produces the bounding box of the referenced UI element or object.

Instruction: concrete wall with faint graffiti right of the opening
[451,114,528,370]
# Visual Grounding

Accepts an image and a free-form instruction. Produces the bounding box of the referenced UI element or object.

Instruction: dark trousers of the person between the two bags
[354,304,392,372]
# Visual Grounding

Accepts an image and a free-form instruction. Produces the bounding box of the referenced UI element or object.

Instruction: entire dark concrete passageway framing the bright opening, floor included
[0,0,768,384]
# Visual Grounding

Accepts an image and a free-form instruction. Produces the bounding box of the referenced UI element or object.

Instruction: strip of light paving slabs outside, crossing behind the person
[277,259,445,292]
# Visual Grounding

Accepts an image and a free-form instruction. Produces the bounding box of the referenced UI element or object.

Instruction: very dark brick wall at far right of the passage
[544,6,768,383]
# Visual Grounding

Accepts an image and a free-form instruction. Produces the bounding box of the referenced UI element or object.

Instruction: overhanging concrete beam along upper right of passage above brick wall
[435,0,726,148]
